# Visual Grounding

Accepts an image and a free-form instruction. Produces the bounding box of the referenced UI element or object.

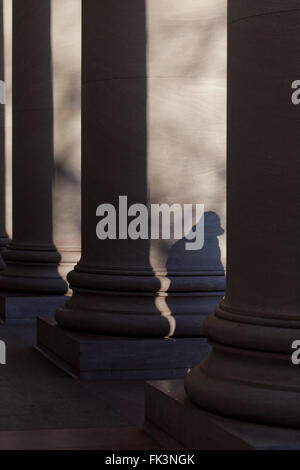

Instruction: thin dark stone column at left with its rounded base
[0,0,66,294]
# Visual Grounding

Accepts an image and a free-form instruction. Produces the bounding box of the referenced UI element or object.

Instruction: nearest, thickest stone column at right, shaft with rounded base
[185,0,300,428]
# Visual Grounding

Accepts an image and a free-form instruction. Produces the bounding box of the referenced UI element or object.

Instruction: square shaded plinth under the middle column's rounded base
[37,318,210,380]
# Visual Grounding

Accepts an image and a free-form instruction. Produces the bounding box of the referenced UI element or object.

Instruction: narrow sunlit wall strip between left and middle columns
[51,0,81,276]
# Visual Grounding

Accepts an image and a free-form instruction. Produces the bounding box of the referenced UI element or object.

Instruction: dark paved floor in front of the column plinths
[0,323,159,450]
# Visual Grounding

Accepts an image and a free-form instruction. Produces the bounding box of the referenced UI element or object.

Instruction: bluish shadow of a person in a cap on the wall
[166,211,225,336]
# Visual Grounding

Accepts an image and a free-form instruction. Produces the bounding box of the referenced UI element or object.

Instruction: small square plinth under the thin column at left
[0,293,68,323]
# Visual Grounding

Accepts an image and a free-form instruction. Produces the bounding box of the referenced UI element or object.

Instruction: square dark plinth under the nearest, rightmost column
[145,380,300,450]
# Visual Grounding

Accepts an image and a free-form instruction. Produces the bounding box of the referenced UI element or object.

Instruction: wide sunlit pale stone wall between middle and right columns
[147,0,227,267]
